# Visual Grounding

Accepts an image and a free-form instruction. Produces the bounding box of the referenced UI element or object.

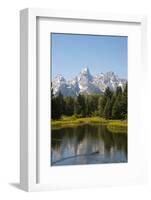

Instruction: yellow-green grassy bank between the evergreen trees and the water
[51,116,127,133]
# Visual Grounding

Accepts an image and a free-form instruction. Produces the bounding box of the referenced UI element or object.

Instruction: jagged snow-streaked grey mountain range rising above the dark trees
[52,68,127,96]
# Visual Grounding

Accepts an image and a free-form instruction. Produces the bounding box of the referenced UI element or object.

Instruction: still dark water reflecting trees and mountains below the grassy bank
[51,125,127,166]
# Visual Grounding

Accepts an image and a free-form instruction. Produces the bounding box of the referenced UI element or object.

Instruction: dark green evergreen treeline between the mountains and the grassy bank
[51,84,127,120]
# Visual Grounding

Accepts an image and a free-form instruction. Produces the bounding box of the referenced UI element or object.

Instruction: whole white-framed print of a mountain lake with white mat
[20,9,147,191]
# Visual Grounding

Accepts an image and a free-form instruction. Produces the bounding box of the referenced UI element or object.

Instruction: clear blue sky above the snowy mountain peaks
[50,33,128,80]
